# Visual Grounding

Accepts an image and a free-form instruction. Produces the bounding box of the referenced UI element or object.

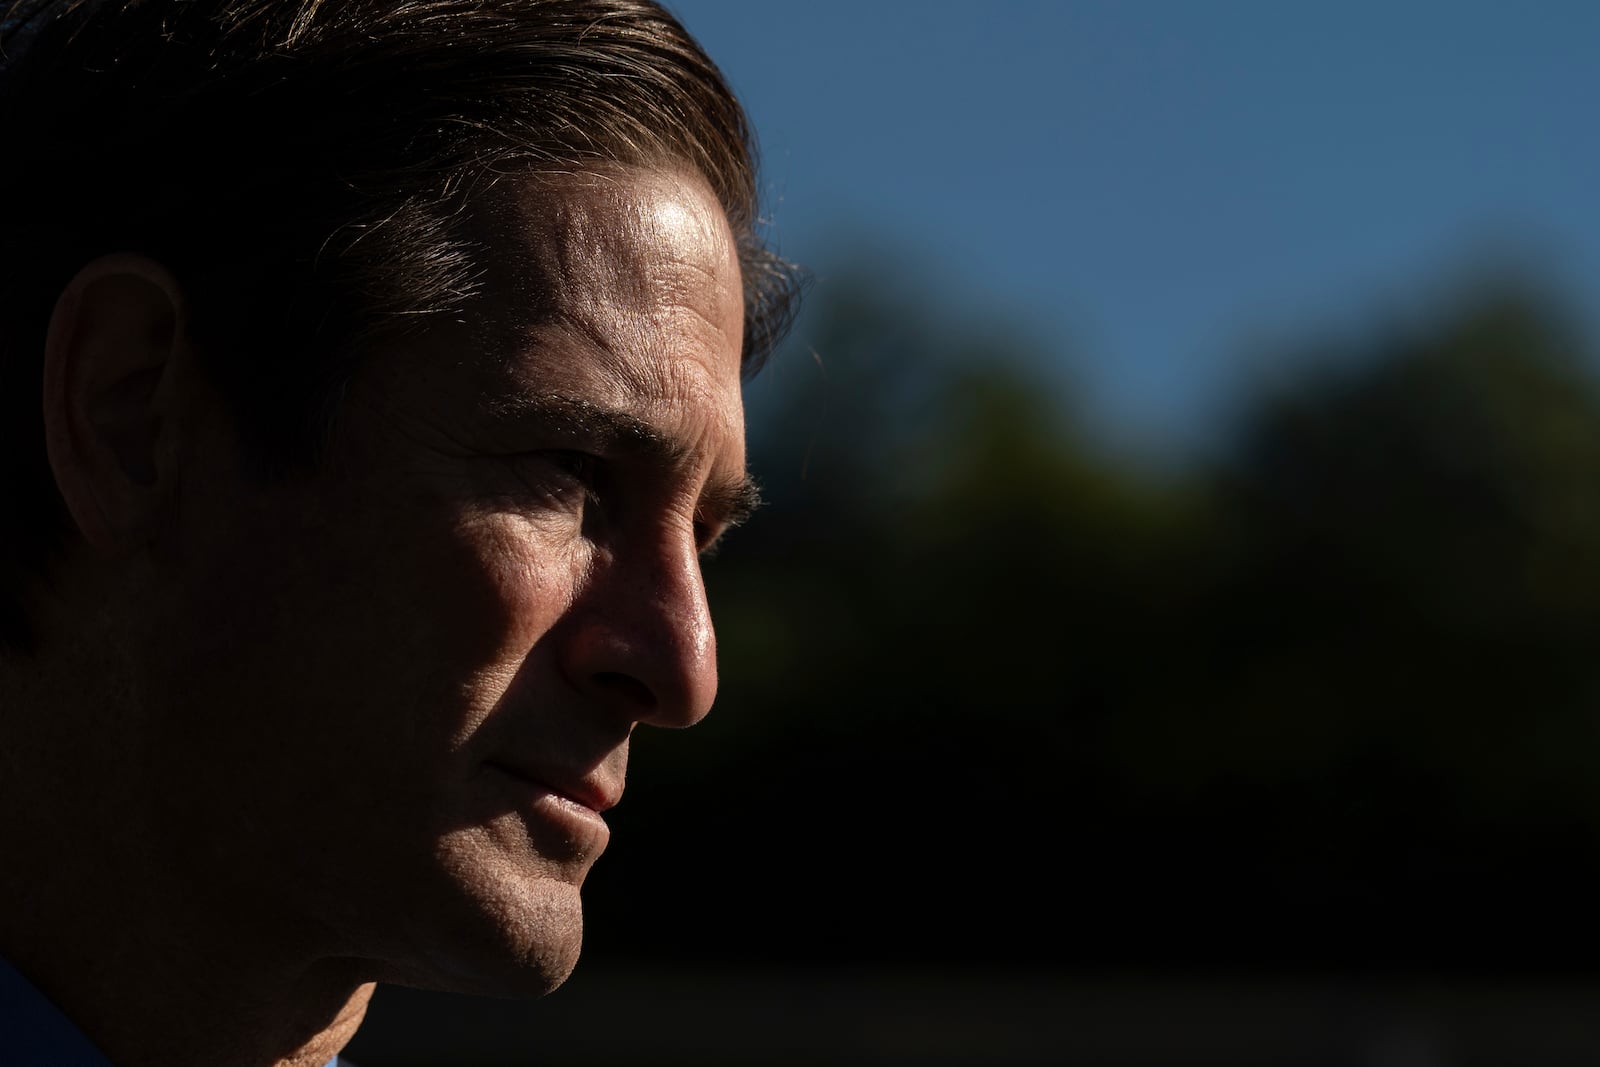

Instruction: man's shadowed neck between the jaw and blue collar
[0,646,373,1067]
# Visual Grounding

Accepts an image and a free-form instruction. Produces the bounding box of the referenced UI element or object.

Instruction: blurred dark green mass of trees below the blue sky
[590,265,1600,968]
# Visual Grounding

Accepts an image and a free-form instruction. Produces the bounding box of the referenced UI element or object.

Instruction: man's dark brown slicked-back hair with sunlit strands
[0,0,797,646]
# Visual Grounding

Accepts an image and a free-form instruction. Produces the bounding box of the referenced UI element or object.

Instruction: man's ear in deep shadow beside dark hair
[45,256,187,553]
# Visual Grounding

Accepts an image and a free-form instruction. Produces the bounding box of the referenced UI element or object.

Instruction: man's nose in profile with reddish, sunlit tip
[566,534,717,728]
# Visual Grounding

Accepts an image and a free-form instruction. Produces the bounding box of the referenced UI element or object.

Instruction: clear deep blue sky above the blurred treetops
[669,0,1600,463]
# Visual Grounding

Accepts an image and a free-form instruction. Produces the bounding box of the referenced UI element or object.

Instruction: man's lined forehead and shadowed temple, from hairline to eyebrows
[362,168,744,467]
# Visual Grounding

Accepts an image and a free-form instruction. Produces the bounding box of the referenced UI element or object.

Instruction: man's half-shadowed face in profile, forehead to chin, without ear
[130,168,749,993]
